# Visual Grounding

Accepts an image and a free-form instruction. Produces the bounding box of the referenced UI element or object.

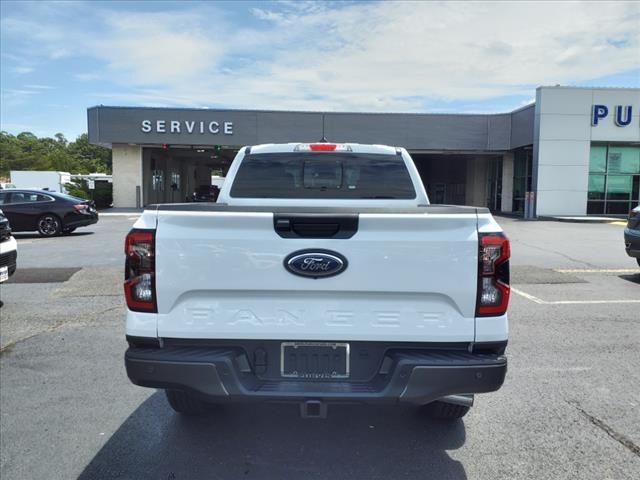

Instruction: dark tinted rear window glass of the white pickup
[231,152,416,200]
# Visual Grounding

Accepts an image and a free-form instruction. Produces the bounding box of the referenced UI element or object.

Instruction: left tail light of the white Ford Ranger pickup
[124,229,158,313]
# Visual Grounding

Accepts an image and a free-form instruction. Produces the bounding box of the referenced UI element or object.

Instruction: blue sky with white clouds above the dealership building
[0,0,640,139]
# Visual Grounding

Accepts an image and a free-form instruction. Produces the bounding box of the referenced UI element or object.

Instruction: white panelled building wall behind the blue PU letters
[534,87,640,216]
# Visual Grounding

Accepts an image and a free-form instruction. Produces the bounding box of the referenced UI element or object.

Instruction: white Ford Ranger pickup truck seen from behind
[124,143,509,418]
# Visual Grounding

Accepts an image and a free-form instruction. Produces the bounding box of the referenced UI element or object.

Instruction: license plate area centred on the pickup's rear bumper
[280,342,349,380]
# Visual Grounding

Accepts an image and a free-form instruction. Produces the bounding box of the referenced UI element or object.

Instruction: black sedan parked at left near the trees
[0,188,98,237]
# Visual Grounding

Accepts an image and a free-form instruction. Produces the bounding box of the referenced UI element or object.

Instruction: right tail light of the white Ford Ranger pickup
[476,233,511,317]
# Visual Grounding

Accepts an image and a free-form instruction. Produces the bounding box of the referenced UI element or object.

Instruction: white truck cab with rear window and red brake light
[218,142,429,208]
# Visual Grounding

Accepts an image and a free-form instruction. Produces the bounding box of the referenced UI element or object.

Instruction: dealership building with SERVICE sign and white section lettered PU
[87,86,640,216]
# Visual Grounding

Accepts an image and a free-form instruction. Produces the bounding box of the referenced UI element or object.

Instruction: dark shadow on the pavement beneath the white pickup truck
[79,392,467,480]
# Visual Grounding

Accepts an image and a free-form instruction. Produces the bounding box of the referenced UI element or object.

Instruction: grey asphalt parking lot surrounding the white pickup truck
[0,215,640,480]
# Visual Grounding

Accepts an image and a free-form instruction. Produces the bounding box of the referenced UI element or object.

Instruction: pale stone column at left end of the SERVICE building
[111,144,143,208]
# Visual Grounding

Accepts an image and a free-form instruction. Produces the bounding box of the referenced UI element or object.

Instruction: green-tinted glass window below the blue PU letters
[587,144,640,215]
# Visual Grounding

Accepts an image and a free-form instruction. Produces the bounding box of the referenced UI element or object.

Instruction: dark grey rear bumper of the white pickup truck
[125,347,507,405]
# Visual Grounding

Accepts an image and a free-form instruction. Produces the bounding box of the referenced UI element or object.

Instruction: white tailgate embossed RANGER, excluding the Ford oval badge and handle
[156,211,478,342]
